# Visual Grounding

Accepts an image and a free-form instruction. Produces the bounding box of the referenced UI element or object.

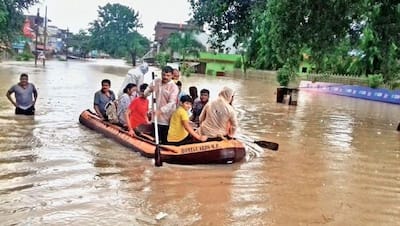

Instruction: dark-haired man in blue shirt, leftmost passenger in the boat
[93,79,115,120]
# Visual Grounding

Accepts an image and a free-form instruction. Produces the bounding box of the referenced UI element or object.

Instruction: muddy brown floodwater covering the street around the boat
[0,60,400,225]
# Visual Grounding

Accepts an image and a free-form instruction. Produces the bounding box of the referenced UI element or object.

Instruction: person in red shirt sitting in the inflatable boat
[125,83,150,136]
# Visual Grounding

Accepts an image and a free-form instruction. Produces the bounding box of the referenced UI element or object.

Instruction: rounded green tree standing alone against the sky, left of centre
[89,3,150,66]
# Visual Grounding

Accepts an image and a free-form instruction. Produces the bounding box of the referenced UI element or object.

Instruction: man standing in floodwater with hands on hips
[6,74,37,115]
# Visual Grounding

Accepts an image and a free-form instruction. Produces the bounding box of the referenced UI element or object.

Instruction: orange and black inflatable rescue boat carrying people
[79,110,246,164]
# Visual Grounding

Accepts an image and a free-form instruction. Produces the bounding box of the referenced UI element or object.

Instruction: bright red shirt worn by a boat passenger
[129,97,149,129]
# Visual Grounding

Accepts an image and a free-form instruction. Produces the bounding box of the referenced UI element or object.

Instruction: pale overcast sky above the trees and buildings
[28,0,191,40]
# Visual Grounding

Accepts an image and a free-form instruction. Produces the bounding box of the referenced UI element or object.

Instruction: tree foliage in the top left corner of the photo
[0,0,39,44]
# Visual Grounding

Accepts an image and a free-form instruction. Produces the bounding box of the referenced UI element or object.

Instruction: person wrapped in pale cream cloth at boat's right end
[197,87,238,138]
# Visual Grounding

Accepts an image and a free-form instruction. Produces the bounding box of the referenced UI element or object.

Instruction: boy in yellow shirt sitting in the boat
[167,95,208,145]
